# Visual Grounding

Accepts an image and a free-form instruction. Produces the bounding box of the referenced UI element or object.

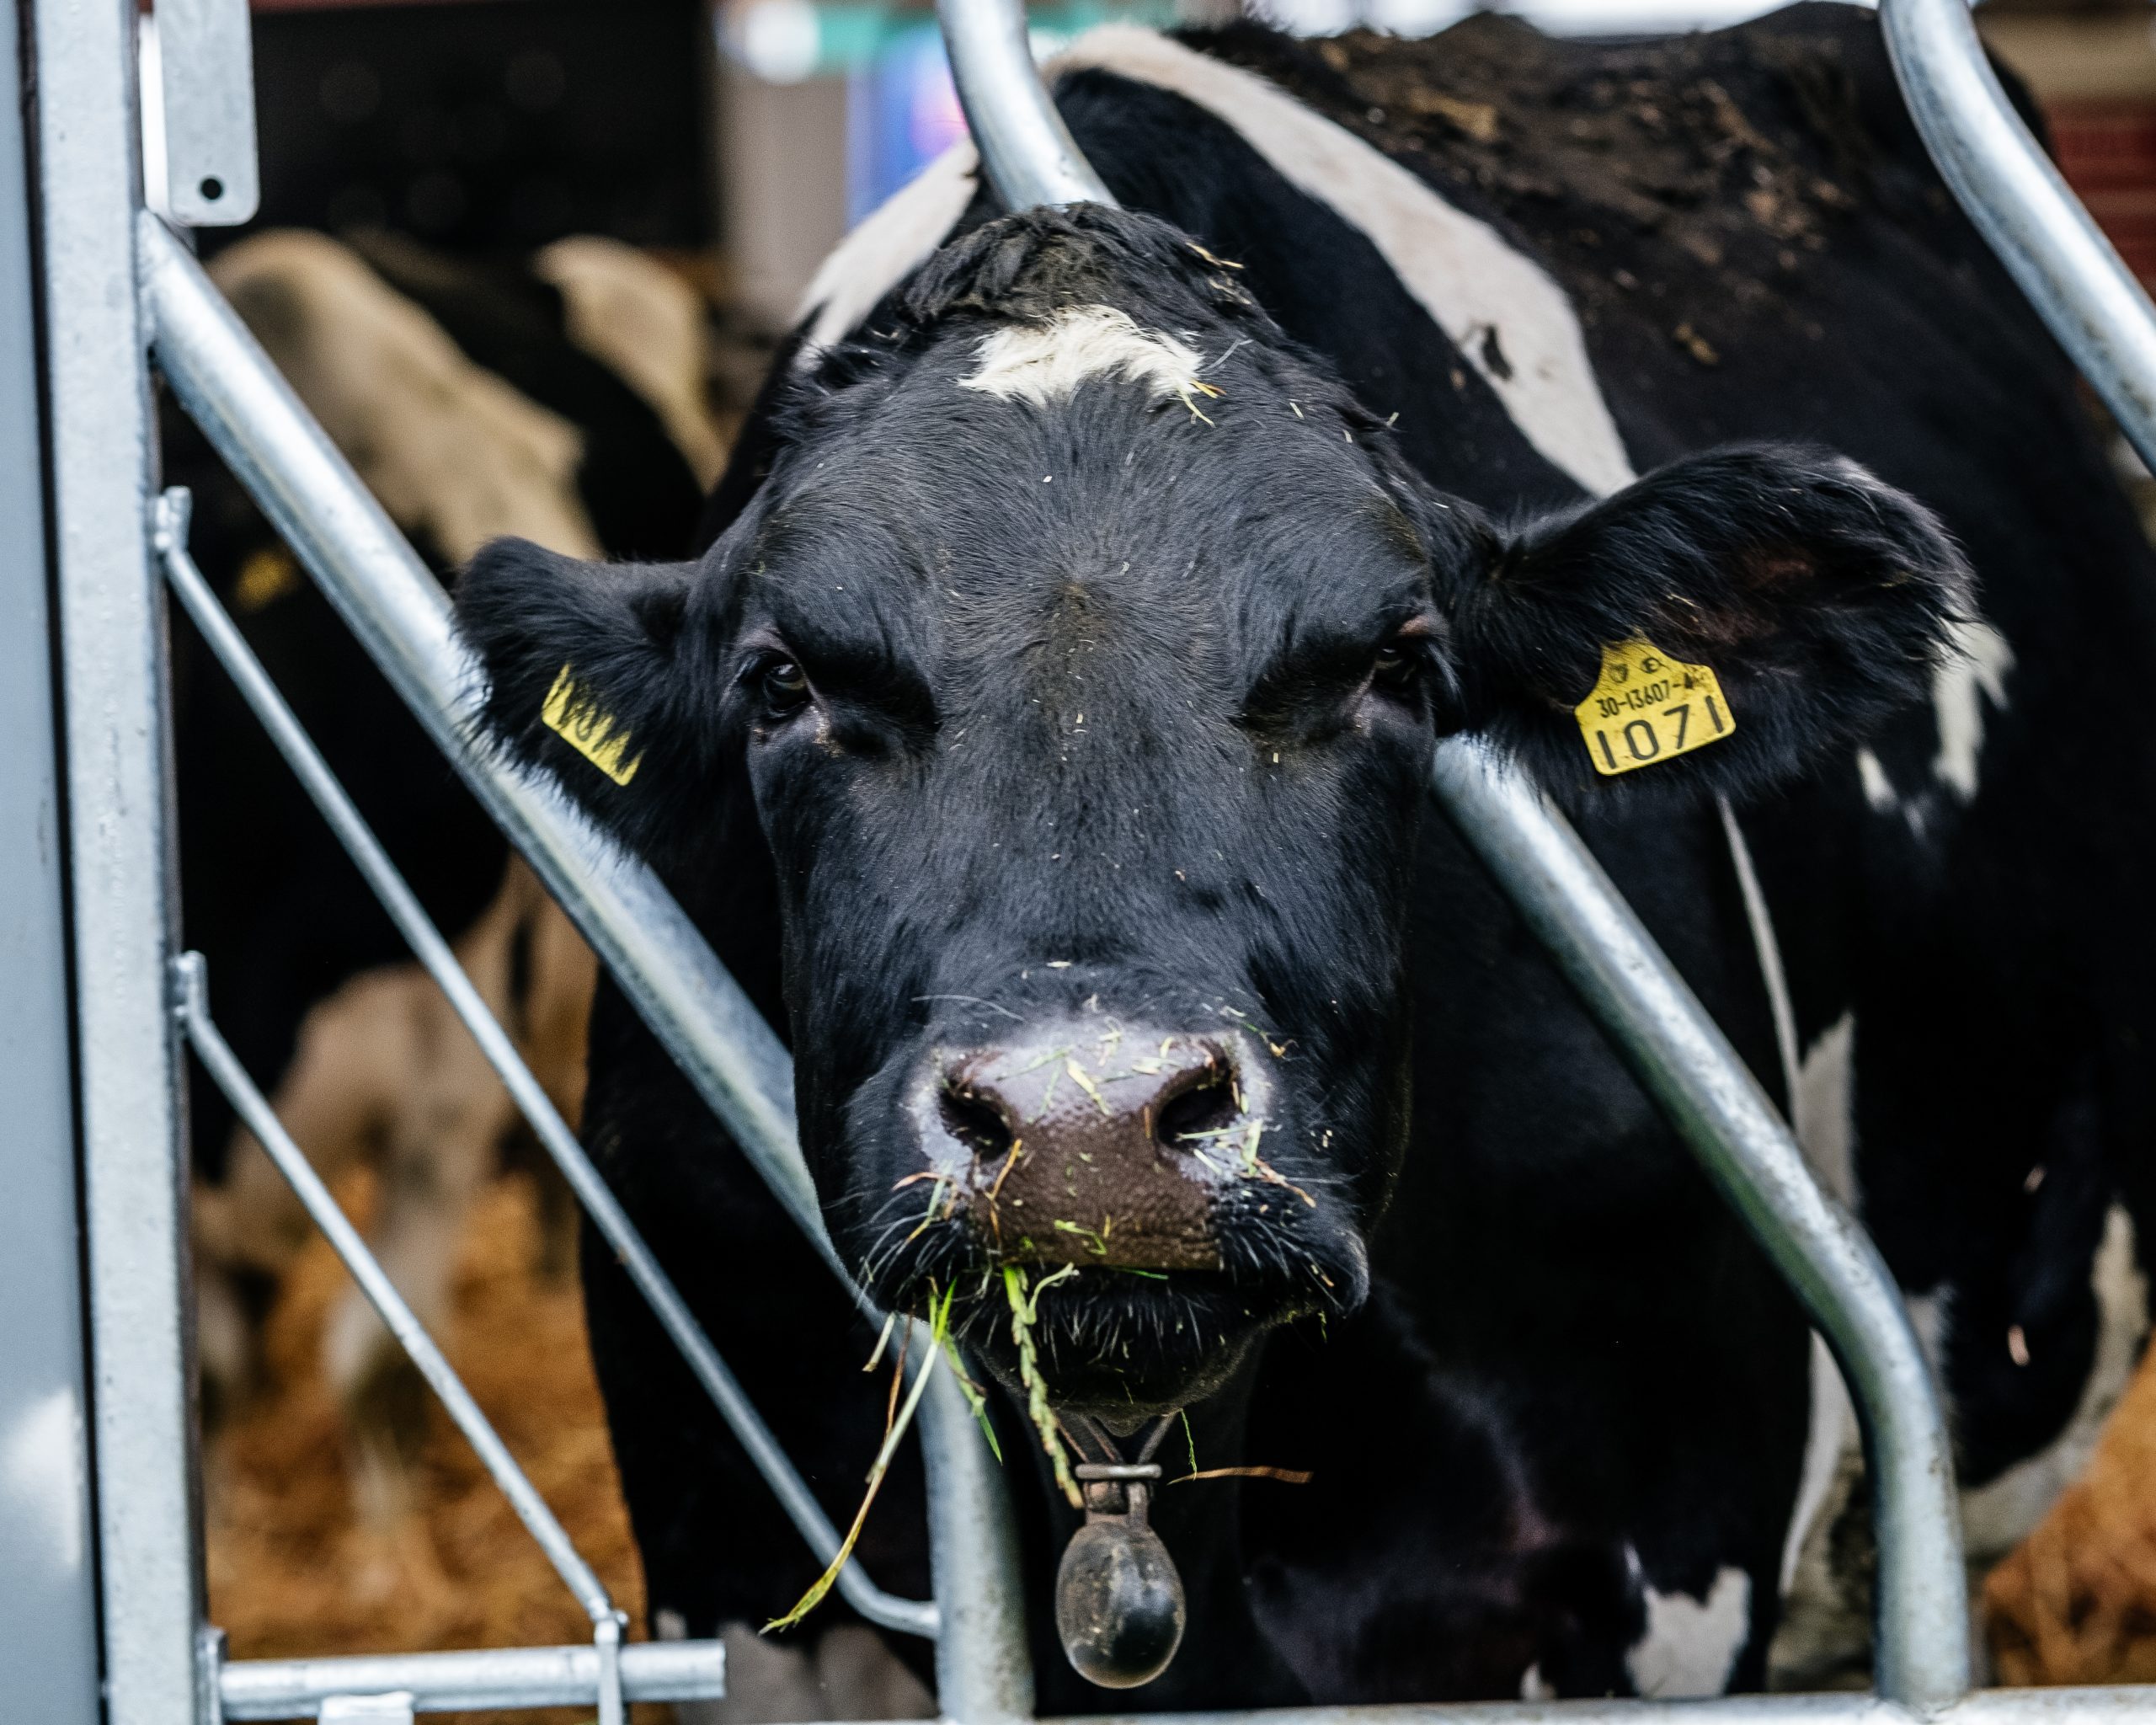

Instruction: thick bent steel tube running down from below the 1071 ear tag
[1432,738,1971,1712]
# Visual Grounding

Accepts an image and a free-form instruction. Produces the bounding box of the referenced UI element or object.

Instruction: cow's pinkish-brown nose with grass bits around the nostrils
[929,1027,1270,1270]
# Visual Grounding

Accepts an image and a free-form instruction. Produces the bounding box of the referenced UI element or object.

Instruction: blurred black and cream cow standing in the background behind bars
[179,231,727,1512]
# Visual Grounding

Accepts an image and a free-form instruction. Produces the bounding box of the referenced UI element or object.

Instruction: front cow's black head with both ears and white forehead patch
[459,211,1962,1414]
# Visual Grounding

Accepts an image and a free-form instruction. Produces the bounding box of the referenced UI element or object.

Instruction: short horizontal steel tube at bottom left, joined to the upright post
[218,1641,727,1721]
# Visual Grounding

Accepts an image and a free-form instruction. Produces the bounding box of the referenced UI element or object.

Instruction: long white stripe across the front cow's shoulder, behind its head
[1043,24,1634,496]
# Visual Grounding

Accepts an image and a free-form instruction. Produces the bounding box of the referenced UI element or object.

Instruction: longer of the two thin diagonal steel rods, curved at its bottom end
[155,498,936,1637]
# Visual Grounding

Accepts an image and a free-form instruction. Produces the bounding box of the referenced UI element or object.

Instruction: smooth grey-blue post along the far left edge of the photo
[0,0,97,1725]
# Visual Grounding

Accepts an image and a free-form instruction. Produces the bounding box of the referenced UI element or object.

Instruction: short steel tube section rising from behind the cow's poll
[936,0,1115,209]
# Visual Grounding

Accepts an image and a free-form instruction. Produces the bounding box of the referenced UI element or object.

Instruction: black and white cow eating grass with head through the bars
[457,7,2156,1712]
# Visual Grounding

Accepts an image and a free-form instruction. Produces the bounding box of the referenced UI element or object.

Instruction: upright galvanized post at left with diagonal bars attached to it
[30,0,203,1725]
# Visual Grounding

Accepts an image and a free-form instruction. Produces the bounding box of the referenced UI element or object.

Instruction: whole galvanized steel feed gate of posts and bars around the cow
[17,0,2156,1725]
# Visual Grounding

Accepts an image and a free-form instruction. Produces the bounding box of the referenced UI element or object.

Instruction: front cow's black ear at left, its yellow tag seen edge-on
[455,539,716,852]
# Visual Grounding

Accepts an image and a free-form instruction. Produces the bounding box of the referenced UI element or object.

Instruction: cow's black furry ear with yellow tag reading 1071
[1453,446,1972,792]
